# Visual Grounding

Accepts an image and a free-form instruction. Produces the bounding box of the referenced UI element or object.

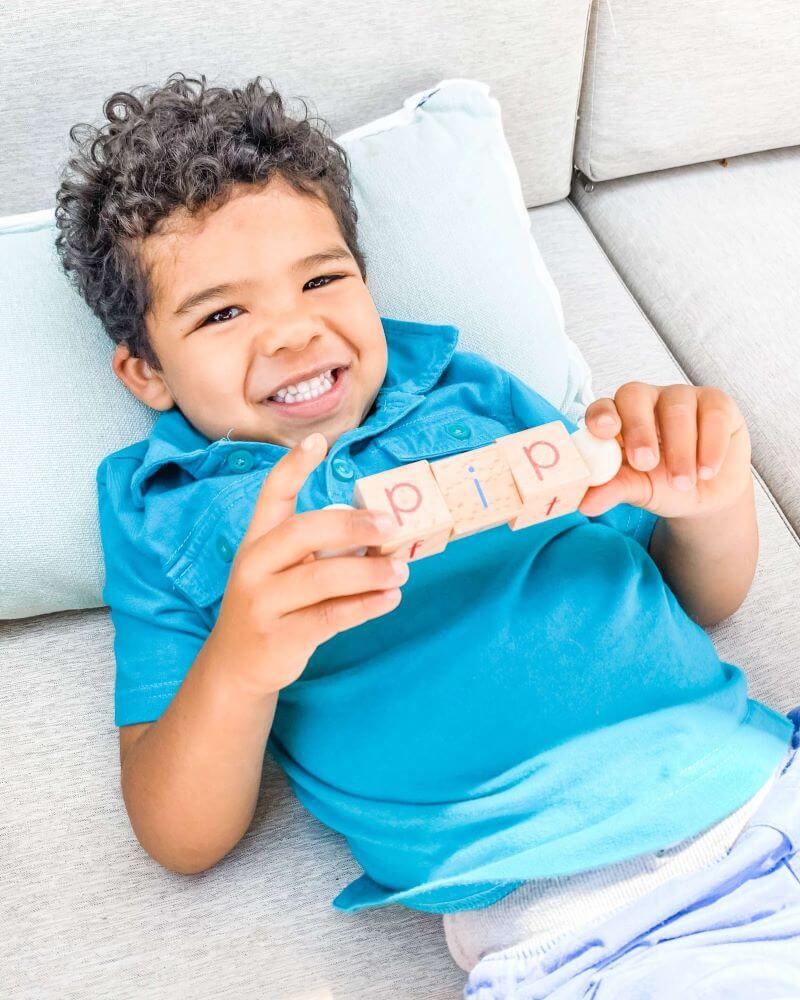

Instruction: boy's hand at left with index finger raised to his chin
[208,433,408,697]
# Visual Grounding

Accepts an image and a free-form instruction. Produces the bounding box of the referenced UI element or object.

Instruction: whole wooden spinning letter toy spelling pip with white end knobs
[316,420,622,562]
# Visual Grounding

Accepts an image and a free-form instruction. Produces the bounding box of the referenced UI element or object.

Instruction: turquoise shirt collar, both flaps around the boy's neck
[131,316,458,506]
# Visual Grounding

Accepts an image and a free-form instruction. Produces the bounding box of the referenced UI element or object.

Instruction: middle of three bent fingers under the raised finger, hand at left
[261,555,410,618]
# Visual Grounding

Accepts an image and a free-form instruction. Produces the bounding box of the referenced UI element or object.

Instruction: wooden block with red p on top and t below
[495,420,591,531]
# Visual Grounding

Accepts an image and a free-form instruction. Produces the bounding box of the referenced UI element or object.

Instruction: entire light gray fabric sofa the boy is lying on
[0,0,800,1000]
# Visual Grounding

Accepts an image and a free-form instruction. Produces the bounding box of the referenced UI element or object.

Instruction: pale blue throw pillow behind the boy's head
[0,80,593,619]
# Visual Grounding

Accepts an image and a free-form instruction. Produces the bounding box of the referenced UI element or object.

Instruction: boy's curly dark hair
[55,73,366,372]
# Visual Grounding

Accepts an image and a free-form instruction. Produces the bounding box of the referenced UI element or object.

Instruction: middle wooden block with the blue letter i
[431,443,522,539]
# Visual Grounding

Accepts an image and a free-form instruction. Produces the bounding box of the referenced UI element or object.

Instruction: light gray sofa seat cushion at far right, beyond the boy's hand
[567,146,800,531]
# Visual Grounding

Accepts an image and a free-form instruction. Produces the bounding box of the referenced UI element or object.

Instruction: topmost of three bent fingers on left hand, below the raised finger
[250,507,396,574]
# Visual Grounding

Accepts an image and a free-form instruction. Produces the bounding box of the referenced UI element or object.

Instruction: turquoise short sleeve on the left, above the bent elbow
[97,465,210,726]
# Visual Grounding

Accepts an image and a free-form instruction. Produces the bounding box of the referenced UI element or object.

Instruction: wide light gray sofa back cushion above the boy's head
[0,0,590,216]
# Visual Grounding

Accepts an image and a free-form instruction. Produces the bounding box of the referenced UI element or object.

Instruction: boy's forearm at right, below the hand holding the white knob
[648,475,758,628]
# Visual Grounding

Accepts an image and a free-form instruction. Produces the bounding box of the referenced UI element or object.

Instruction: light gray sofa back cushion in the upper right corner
[575,0,800,181]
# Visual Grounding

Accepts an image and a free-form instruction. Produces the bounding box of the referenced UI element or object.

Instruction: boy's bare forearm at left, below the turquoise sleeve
[122,632,278,874]
